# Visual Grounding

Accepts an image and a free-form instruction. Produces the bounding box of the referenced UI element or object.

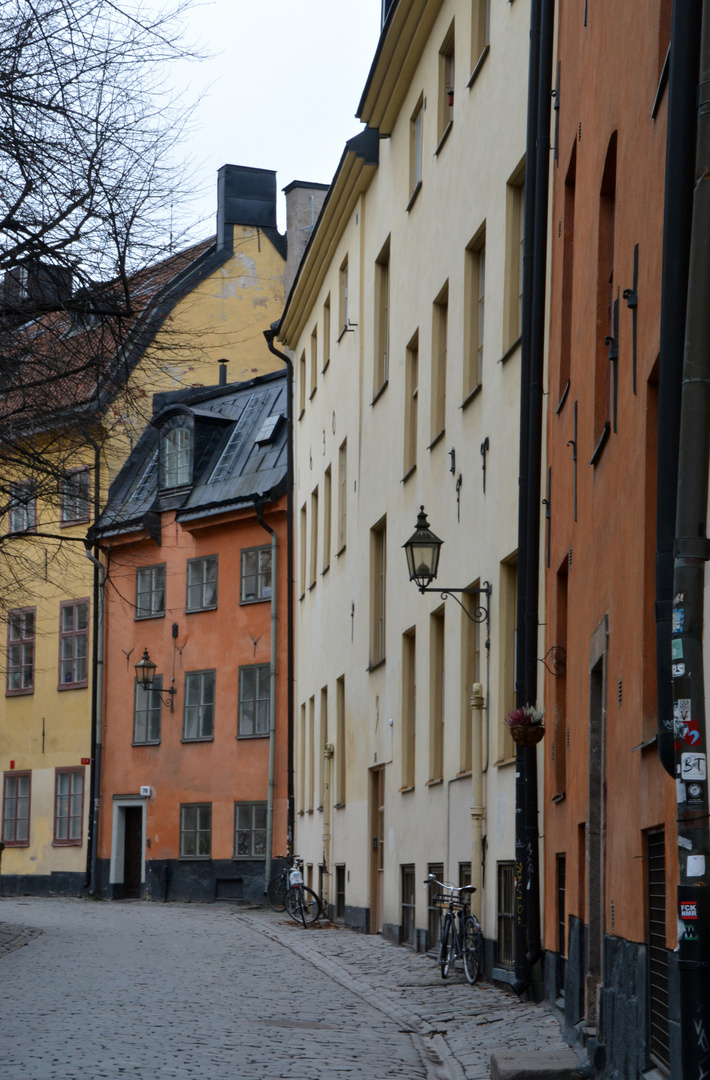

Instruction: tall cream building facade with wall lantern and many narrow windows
[279,0,530,977]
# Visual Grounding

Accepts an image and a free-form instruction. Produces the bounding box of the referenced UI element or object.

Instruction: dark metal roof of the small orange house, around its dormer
[93,372,289,537]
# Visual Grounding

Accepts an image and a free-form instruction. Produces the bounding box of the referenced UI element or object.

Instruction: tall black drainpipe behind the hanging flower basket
[513,0,554,994]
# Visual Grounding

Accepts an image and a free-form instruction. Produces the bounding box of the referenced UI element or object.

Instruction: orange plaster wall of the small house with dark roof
[99,500,287,861]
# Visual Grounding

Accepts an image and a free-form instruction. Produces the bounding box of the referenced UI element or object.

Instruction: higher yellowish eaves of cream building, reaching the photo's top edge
[356,0,443,135]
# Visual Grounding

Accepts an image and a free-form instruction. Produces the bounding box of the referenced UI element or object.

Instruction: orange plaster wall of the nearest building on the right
[544,0,676,951]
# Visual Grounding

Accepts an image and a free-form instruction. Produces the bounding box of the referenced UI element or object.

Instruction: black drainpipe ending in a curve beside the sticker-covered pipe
[656,0,701,777]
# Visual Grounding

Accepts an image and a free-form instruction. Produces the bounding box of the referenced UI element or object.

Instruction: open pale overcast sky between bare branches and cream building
[173,0,381,235]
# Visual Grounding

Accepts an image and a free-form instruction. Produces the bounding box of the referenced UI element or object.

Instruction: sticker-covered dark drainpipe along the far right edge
[671,6,710,1078]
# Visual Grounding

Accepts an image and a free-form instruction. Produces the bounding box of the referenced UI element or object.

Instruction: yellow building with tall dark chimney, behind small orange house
[0,165,286,895]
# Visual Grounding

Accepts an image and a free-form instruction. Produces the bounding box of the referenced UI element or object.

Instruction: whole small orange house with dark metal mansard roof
[96,373,287,901]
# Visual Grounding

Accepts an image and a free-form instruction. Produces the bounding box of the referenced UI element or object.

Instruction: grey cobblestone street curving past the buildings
[0,899,564,1080]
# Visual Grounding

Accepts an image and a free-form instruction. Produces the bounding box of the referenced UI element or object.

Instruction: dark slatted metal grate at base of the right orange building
[646,828,670,1068]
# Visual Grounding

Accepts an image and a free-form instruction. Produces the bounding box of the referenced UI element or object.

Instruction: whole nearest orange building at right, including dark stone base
[544,0,678,1077]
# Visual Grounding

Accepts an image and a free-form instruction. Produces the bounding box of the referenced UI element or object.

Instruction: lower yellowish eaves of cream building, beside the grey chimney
[279,127,379,349]
